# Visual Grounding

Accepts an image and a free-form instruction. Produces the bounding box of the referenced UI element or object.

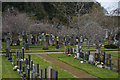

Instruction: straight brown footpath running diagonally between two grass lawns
[39,54,100,80]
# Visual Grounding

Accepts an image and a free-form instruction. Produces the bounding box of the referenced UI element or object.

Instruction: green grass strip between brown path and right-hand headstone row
[48,54,118,78]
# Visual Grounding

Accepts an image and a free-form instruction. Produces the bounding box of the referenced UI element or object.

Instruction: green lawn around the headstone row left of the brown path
[2,54,76,78]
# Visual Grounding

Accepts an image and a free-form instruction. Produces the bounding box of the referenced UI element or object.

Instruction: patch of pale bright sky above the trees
[96,0,120,14]
